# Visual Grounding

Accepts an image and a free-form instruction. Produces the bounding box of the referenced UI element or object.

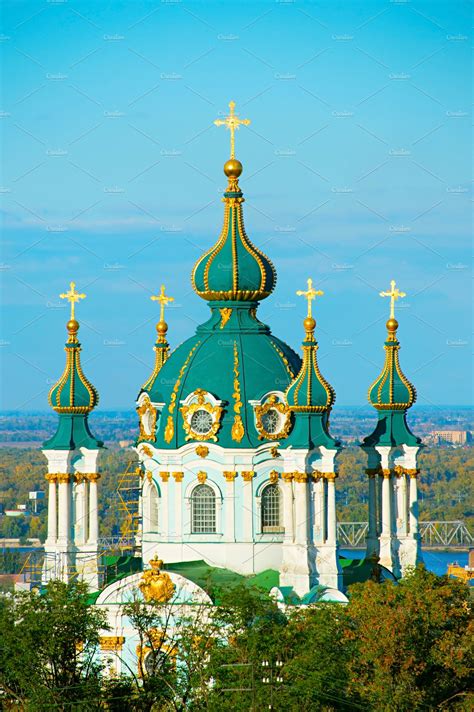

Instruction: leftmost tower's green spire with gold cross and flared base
[45,282,103,449]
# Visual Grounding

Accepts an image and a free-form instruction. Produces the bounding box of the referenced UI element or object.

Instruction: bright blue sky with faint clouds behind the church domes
[0,0,472,409]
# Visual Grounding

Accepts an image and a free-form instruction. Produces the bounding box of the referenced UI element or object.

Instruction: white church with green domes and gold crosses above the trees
[37,102,421,672]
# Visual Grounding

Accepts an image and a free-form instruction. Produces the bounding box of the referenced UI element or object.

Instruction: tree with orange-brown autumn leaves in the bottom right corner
[343,566,474,712]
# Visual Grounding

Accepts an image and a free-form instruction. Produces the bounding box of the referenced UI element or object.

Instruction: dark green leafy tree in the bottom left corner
[0,581,107,710]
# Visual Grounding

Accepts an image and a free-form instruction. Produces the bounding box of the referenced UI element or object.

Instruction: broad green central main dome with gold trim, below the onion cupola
[138,301,301,449]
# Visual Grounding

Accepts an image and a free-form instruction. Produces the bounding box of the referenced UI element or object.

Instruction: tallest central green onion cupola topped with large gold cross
[191,101,276,302]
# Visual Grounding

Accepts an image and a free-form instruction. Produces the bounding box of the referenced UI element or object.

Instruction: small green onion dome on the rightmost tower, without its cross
[368,321,416,410]
